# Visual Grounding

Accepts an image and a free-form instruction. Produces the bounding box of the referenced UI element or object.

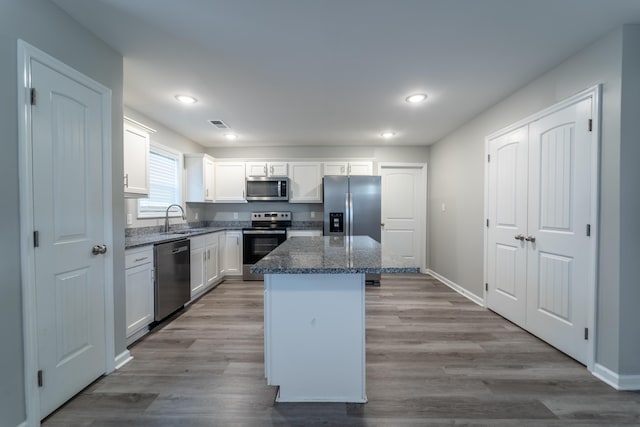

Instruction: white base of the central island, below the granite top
[264,273,367,403]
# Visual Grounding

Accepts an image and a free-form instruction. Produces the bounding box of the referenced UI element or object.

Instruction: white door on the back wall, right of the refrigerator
[380,165,427,267]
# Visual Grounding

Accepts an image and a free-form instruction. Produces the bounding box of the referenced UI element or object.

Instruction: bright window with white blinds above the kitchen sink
[138,143,182,218]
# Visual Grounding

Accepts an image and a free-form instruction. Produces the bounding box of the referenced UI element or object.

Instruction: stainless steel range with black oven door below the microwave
[242,212,291,280]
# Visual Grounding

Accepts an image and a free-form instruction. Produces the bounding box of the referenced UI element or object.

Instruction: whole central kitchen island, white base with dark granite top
[251,236,419,403]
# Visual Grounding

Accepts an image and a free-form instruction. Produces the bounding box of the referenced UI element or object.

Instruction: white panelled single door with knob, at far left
[31,59,106,417]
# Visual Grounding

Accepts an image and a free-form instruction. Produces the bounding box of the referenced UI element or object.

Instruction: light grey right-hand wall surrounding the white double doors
[429,29,640,373]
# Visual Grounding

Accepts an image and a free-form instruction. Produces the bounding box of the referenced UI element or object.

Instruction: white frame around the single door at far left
[18,40,115,426]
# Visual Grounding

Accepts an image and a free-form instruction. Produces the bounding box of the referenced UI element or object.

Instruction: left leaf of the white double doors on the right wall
[487,126,529,327]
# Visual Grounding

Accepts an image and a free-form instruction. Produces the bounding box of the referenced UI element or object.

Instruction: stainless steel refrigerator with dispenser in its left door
[323,175,381,242]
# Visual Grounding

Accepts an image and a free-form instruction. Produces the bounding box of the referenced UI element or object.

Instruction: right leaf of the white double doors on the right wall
[527,99,592,363]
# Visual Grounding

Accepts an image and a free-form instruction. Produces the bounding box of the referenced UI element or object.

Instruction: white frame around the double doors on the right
[483,84,602,372]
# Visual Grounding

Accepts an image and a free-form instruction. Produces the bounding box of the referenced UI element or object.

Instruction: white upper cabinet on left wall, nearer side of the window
[123,120,149,198]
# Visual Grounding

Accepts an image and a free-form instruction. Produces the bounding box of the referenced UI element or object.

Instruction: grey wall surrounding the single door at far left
[0,0,125,426]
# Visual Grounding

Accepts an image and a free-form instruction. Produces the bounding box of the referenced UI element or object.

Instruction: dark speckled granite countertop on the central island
[251,236,420,274]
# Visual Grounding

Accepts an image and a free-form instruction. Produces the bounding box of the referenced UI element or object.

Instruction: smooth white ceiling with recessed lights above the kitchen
[53,0,640,147]
